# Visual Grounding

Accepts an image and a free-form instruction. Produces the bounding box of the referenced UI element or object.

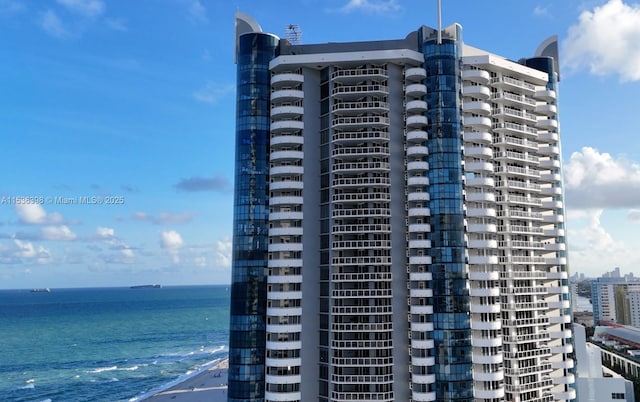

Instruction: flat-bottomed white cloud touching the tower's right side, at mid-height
[564,147,640,208]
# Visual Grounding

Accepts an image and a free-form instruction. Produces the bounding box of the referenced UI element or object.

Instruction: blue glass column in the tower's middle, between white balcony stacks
[423,25,473,402]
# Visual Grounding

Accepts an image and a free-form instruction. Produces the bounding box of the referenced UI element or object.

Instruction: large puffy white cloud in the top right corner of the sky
[563,0,640,81]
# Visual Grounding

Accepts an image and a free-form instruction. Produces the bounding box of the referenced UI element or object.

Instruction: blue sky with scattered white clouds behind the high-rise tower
[0,0,640,288]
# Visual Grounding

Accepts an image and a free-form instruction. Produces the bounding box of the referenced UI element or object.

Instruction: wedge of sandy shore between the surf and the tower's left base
[129,357,229,402]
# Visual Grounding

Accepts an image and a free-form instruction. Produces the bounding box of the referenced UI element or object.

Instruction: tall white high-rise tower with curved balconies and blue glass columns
[228,14,575,402]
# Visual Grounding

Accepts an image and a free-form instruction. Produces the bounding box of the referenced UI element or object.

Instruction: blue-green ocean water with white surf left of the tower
[0,286,229,402]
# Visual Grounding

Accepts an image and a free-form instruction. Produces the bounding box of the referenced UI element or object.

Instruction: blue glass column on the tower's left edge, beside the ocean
[228,33,278,402]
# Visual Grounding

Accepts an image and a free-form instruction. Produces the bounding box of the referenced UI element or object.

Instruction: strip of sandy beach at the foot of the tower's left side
[143,359,229,402]
